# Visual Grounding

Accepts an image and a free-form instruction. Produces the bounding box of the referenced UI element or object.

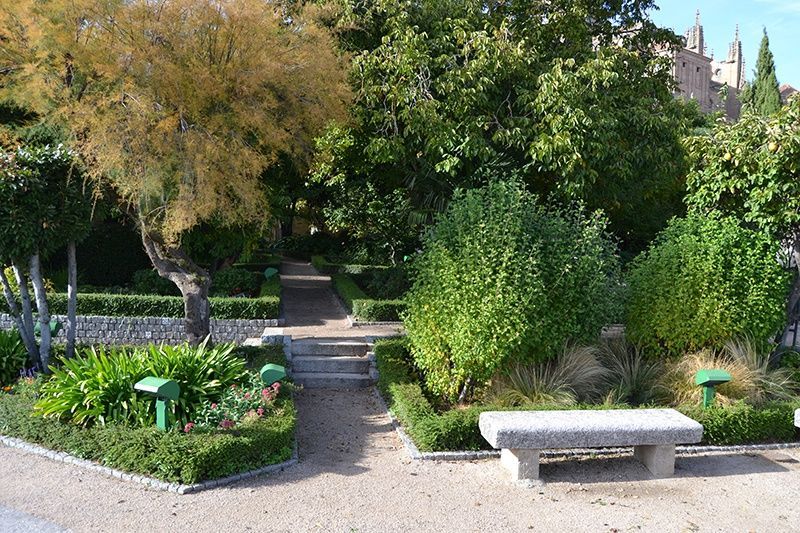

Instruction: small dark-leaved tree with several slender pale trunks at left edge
[0,145,91,371]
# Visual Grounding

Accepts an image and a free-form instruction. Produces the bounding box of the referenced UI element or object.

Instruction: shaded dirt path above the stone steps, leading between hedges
[281,259,404,339]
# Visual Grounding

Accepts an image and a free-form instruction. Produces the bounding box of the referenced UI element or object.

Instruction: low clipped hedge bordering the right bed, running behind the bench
[375,339,800,452]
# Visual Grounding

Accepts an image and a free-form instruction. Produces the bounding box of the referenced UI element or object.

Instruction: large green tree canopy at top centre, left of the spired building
[316,0,691,258]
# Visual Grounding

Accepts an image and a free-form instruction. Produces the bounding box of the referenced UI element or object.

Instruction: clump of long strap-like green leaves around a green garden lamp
[36,343,245,426]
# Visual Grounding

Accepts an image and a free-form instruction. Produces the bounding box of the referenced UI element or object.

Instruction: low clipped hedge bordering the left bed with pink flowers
[0,378,296,484]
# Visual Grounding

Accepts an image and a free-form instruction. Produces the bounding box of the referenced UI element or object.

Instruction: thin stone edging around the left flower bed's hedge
[0,435,298,494]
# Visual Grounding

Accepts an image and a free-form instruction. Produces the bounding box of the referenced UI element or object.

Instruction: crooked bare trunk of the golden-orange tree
[140,224,211,346]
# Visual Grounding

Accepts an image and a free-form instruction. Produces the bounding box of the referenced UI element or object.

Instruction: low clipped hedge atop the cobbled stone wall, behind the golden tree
[0,293,280,320]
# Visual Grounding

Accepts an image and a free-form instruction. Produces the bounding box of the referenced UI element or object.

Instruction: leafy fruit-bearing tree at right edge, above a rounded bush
[687,98,800,330]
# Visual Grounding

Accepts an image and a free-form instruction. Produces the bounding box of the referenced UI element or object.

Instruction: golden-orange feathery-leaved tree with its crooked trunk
[0,0,347,342]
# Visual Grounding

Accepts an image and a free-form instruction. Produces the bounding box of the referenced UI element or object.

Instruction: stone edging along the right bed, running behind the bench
[374,388,800,461]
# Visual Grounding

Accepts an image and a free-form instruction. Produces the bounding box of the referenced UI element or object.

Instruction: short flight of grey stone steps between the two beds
[291,338,375,389]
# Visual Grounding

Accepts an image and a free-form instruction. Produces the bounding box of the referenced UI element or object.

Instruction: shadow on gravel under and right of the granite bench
[539,454,790,484]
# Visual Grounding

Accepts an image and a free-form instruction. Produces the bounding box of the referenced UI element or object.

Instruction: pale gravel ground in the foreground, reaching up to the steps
[0,390,800,532]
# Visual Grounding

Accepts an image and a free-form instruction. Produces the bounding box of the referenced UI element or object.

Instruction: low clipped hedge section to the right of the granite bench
[678,401,800,446]
